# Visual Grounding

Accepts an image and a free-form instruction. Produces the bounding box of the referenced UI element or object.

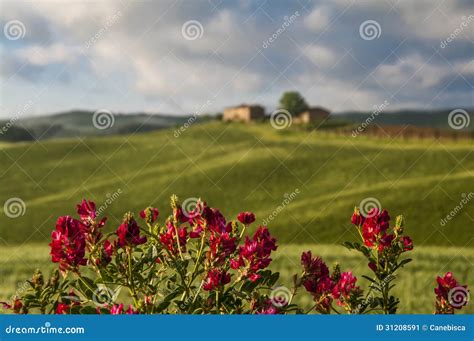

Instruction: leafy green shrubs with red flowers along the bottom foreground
[3,196,468,314]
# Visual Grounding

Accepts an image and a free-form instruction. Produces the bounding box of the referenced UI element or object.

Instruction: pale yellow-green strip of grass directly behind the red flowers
[0,243,474,314]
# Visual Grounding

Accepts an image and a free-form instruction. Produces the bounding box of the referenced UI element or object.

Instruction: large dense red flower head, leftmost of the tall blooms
[49,216,87,271]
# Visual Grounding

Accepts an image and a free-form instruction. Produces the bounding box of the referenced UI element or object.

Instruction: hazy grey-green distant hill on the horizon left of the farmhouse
[0,110,205,141]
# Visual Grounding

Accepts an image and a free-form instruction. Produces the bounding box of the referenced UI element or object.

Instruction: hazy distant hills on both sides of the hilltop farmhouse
[0,108,474,142]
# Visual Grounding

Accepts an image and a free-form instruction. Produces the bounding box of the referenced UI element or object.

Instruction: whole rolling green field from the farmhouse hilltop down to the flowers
[0,122,474,313]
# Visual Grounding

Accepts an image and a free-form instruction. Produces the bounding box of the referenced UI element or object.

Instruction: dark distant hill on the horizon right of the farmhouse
[331,108,474,131]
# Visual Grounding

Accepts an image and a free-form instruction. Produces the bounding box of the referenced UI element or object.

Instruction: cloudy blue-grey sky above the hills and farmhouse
[0,0,474,118]
